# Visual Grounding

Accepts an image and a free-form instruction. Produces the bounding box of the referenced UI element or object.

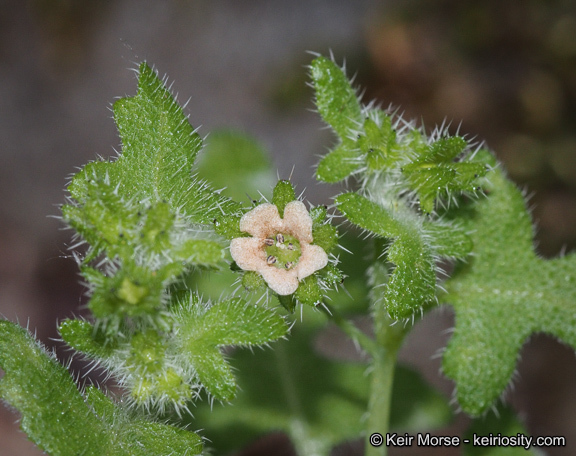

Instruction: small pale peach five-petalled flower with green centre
[230,201,328,295]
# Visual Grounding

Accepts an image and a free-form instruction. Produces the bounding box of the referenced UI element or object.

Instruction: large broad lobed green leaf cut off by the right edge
[443,154,576,415]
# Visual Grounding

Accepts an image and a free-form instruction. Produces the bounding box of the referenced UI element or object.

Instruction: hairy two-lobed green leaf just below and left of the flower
[173,298,288,401]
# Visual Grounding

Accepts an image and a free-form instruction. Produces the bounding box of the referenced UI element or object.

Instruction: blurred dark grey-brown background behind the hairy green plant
[0,0,576,456]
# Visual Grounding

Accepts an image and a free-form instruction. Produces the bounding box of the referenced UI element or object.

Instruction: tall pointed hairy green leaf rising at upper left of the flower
[69,63,239,223]
